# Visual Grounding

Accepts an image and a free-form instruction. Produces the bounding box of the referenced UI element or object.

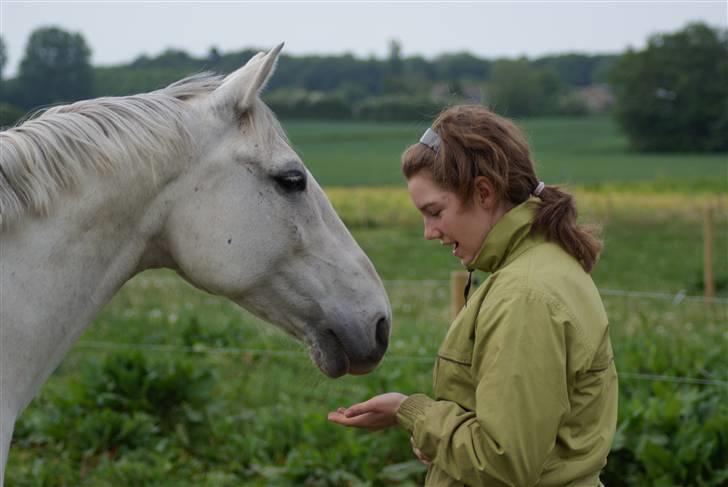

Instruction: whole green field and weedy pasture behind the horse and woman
[6,119,728,486]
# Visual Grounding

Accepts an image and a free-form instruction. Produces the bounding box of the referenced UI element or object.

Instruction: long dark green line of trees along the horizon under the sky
[0,24,728,151]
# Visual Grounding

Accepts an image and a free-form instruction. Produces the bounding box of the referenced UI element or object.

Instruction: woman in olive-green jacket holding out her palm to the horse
[329,105,617,487]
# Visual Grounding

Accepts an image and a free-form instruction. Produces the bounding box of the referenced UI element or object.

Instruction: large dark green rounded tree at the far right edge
[611,23,728,151]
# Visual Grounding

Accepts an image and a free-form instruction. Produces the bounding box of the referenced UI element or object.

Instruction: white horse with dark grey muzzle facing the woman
[0,44,391,478]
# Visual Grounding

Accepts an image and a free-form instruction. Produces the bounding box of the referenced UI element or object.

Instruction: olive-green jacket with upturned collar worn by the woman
[397,198,617,487]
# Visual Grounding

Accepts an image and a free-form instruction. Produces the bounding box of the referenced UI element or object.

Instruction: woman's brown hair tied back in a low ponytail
[402,105,602,272]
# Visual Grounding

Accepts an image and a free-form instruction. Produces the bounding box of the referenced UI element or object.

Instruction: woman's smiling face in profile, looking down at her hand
[407,171,504,265]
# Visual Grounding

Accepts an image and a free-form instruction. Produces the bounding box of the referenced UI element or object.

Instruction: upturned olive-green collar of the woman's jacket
[467,197,542,272]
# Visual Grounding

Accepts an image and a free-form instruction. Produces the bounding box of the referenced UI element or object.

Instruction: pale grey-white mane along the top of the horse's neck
[0,73,222,230]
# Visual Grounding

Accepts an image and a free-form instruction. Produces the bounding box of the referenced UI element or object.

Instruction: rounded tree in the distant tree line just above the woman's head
[486,59,561,117]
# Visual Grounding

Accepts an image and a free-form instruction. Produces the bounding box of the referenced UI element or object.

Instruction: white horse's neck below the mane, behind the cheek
[0,158,179,415]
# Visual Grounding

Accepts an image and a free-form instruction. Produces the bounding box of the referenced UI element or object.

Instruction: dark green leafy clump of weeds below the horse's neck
[14,352,214,470]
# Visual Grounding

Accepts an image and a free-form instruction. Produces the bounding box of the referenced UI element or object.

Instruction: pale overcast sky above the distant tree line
[0,0,728,76]
